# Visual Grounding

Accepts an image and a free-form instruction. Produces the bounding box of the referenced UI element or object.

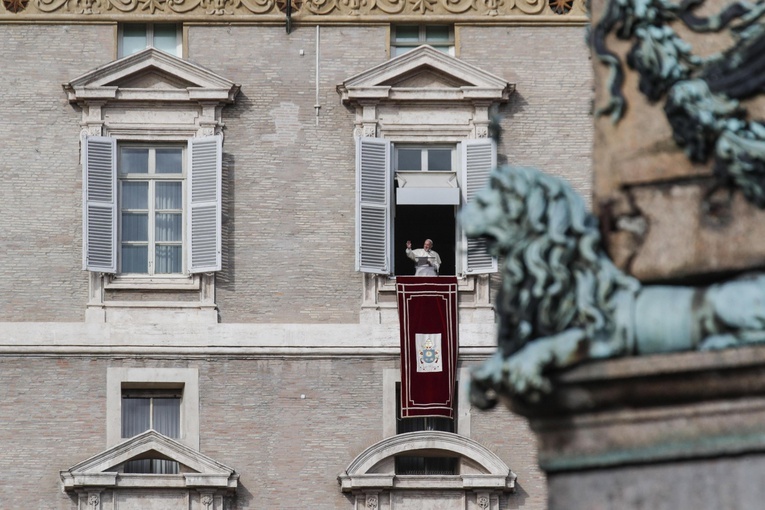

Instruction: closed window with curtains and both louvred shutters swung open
[83,136,222,275]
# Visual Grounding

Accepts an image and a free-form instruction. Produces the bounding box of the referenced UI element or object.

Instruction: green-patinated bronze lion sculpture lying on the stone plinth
[461,166,765,408]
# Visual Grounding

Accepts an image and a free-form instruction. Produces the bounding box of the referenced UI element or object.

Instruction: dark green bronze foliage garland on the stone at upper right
[591,0,765,208]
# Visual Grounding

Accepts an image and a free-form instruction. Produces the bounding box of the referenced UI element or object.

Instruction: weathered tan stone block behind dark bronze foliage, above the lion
[592,0,765,282]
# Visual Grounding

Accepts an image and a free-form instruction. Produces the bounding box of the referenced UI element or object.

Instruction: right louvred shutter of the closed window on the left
[186,135,223,273]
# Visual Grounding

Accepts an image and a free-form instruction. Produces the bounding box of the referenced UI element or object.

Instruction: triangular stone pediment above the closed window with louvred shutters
[64,48,239,102]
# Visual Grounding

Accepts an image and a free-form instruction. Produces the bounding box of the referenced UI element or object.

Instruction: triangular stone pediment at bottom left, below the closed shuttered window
[61,430,239,489]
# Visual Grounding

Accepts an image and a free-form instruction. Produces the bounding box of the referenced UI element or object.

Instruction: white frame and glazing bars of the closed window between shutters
[114,140,189,276]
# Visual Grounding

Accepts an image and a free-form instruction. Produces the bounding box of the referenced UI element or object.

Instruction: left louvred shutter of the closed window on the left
[82,136,117,273]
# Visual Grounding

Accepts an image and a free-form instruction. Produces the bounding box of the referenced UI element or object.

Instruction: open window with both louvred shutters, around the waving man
[357,138,496,275]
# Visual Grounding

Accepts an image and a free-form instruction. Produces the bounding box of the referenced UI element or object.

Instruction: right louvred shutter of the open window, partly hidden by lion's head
[462,138,497,274]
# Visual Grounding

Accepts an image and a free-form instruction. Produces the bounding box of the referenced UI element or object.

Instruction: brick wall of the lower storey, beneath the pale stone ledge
[0,357,545,510]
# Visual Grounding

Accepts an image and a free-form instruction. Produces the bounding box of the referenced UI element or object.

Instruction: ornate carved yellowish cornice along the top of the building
[0,0,588,24]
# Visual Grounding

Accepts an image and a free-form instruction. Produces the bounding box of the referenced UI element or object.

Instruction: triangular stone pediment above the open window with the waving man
[337,45,515,102]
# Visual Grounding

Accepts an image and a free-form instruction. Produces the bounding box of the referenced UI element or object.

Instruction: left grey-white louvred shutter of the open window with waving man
[356,138,391,274]
